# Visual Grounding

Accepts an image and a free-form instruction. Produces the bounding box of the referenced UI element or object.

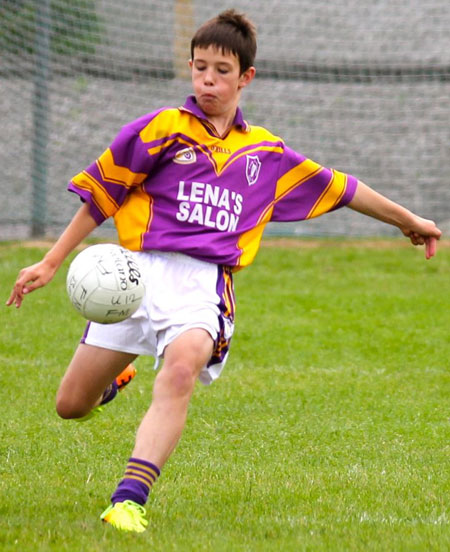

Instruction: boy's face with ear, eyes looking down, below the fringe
[190,46,255,116]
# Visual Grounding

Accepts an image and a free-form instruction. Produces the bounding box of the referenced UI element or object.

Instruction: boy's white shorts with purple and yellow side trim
[81,251,235,385]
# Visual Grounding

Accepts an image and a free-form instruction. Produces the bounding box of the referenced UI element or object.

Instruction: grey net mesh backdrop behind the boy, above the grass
[0,0,450,240]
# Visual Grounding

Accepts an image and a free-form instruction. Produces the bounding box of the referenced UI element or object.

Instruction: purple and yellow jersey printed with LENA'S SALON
[69,96,357,269]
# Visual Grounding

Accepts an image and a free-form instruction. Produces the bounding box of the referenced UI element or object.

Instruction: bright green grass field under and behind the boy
[0,240,450,552]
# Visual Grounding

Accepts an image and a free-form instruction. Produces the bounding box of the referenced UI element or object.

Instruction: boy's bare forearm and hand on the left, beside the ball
[6,203,97,308]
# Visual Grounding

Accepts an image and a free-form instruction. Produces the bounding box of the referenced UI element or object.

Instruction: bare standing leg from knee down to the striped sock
[132,329,213,468]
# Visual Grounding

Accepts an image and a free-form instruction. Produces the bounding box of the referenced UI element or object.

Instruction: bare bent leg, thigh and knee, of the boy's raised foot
[56,344,137,418]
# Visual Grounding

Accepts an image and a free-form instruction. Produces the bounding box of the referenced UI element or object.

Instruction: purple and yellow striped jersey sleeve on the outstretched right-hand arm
[271,146,358,222]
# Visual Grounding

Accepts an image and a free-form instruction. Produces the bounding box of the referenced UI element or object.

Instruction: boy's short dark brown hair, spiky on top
[191,10,256,75]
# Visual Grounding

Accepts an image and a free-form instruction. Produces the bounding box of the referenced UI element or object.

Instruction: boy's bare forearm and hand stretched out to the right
[347,181,441,259]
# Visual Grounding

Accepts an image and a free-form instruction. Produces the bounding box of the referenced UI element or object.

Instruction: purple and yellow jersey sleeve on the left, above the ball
[68,112,162,224]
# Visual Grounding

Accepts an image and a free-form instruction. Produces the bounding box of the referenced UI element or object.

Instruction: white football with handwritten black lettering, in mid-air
[66,243,145,324]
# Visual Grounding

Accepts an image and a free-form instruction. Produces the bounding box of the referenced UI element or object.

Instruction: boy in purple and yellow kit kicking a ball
[7,10,441,532]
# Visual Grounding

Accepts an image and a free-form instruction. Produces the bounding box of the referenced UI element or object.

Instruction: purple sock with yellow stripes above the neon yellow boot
[111,458,160,506]
